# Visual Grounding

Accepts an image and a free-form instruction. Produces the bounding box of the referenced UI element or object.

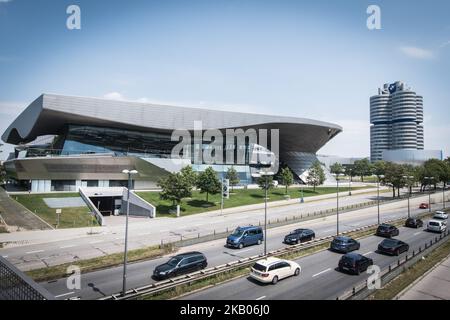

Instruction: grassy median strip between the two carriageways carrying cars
[140,219,404,300]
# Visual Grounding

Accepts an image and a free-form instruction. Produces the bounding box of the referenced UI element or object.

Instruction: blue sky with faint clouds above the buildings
[0,0,450,158]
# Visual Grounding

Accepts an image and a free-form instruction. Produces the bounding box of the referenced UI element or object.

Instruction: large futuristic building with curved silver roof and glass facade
[2,94,342,192]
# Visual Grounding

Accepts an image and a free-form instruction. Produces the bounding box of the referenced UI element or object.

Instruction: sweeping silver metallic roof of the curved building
[2,94,342,152]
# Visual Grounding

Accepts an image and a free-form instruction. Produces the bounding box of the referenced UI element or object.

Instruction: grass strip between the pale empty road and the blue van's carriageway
[26,245,176,281]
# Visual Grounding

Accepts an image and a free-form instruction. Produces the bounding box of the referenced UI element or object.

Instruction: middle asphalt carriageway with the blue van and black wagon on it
[42,194,446,299]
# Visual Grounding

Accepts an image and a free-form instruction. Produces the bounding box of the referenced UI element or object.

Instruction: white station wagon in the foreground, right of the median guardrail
[250,257,302,284]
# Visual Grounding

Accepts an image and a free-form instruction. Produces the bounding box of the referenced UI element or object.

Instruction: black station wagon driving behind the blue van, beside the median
[153,252,208,280]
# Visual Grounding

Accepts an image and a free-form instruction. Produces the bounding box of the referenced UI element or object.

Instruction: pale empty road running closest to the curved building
[0,191,398,271]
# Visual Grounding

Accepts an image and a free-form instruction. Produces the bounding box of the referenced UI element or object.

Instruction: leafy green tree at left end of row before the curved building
[158,172,192,206]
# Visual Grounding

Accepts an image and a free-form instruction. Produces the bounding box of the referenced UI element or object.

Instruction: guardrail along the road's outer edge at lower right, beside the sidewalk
[336,230,450,300]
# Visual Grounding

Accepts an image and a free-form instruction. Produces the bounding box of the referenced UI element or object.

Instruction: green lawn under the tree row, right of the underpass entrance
[137,187,367,216]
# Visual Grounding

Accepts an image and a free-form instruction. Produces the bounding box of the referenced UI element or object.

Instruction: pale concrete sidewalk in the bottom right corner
[397,256,450,300]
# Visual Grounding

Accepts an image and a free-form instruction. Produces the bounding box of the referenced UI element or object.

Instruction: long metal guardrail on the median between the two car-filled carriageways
[99,218,404,300]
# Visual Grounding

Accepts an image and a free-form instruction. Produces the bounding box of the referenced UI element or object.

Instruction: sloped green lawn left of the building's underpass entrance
[11,193,98,228]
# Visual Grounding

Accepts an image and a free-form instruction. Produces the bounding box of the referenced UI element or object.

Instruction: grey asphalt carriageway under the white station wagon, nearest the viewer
[183,220,444,300]
